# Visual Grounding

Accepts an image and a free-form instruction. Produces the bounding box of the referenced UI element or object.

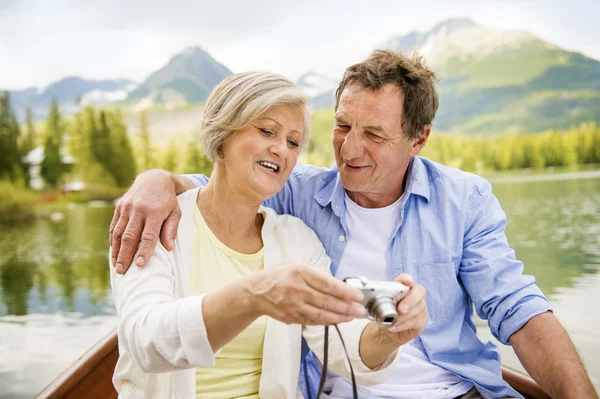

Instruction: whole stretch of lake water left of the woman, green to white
[0,205,116,398]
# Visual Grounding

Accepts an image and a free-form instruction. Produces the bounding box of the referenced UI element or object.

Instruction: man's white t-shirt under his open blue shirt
[324,195,473,399]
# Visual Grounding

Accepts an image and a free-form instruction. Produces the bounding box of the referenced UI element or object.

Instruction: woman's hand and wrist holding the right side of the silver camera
[360,274,429,369]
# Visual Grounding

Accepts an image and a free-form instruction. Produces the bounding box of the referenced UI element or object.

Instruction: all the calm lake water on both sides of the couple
[0,172,600,399]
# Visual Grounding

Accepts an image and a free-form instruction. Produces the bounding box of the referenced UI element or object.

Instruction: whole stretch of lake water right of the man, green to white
[486,178,600,390]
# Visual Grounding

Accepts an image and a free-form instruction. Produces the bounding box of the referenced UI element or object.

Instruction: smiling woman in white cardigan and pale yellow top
[111,72,406,399]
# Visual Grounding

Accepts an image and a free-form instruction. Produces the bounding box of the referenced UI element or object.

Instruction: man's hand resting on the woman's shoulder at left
[110,170,193,274]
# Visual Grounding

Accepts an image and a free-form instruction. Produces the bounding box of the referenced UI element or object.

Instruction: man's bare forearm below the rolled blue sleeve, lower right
[510,312,598,398]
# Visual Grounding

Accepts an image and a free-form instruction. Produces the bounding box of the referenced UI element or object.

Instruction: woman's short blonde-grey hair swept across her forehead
[200,72,311,162]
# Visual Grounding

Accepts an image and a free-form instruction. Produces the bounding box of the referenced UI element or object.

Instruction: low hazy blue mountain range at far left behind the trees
[4,77,136,120]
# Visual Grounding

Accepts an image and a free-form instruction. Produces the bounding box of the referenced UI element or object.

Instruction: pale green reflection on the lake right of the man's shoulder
[493,175,600,295]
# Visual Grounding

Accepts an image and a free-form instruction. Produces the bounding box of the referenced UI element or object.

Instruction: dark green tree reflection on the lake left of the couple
[0,206,112,316]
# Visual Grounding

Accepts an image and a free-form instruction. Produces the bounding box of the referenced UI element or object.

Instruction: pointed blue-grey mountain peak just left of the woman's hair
[127,47,231,108]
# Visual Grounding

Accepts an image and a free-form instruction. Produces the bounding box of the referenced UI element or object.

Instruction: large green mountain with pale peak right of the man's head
[378,19,600,134]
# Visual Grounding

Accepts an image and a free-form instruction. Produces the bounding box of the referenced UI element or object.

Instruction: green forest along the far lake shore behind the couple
[0,93,600,220]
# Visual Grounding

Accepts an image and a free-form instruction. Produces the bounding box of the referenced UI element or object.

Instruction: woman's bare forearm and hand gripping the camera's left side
[202,264,365,351]
